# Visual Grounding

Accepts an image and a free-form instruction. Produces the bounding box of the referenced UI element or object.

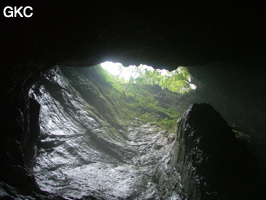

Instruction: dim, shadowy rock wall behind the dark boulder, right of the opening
[189,66,266,180]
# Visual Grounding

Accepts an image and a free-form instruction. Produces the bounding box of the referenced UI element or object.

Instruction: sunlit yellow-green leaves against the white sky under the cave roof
[101,64,195,94]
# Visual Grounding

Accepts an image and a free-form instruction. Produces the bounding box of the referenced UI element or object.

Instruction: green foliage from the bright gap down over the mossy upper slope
[92,63,192,130]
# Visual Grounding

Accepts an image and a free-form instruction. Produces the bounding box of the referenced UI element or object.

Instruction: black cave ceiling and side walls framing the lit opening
[0,0,266,199]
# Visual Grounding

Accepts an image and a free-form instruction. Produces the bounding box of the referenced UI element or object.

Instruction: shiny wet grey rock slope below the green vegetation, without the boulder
[31,68,182,199]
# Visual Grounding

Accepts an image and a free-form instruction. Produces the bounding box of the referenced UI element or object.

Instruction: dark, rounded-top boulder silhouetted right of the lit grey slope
[175,103,256,200]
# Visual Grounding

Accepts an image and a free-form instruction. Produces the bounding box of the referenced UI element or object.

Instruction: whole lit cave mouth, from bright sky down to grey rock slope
[29,62,196,199]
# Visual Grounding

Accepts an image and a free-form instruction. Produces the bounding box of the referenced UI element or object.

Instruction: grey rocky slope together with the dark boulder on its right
[0,67,263,200]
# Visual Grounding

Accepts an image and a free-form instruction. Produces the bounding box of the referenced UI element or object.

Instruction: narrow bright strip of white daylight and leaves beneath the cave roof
[100,61,196,94]
